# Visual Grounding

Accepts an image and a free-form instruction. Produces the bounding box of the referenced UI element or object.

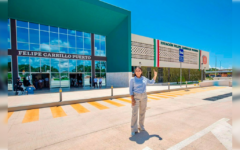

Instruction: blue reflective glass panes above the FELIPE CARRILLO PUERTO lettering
[15,20,92,56]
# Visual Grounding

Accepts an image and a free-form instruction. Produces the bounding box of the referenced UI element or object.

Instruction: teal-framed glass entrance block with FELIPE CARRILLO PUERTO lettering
[8,0,131,89]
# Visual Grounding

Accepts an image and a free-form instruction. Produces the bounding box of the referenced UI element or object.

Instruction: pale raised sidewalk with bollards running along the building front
[8,85,196,108]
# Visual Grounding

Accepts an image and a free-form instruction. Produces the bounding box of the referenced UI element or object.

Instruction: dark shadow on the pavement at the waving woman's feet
[129,131,162,144]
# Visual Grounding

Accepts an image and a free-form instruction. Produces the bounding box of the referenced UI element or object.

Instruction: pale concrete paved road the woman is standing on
[8,87,232,150]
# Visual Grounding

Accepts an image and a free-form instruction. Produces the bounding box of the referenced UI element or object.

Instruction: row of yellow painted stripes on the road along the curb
[5,87,225,123]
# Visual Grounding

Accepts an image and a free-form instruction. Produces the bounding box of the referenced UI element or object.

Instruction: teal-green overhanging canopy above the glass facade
[8,0,130,35]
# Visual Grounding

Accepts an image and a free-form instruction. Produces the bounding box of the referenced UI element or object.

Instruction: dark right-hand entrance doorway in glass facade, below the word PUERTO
[70,73,84,88]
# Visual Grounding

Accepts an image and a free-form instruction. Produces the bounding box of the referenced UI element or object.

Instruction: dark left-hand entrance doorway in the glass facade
[32,73,50,90]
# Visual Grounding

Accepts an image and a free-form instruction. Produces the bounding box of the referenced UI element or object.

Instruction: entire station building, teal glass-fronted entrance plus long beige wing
[8,0,209,90]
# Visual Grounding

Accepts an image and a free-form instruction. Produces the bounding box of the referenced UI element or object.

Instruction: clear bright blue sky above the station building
[102,0,232,68]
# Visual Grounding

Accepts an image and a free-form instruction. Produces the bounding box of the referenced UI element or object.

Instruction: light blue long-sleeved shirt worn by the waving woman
[129,76,155,95]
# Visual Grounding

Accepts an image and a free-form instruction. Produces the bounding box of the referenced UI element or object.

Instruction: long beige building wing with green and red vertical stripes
[131,34,209,83]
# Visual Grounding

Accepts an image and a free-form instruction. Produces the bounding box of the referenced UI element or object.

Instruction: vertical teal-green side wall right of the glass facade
[106,16,132,72]
